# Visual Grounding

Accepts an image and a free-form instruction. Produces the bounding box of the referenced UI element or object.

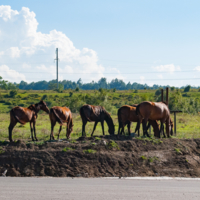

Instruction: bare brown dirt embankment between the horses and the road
[0,136,200,177]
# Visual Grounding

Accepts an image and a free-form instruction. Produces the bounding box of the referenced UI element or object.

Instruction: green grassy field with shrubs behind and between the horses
[0,89,200,140]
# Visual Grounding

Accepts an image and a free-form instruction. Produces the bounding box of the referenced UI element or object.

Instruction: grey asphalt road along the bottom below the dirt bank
[0,177,200,200]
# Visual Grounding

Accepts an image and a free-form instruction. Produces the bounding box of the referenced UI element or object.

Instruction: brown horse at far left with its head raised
[8,101,49,142]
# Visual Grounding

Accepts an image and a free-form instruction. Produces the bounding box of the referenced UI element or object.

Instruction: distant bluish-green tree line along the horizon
[0,76,198,90]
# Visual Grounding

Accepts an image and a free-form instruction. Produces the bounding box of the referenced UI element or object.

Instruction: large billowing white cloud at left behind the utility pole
[0,6,112,82]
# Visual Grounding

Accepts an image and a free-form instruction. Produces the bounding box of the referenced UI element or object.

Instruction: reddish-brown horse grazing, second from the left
[49,106,73,140]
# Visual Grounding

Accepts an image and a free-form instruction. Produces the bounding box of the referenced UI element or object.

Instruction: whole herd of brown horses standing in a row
[8,101,173,142]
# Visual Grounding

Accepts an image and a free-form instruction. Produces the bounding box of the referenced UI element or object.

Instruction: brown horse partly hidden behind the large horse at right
[118,104,159,137]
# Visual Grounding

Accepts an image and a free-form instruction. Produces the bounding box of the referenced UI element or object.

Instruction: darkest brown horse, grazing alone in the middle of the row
[80,104,115,136]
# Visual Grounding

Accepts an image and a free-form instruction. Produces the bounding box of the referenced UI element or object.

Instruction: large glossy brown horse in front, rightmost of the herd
[136,101,173,137]
